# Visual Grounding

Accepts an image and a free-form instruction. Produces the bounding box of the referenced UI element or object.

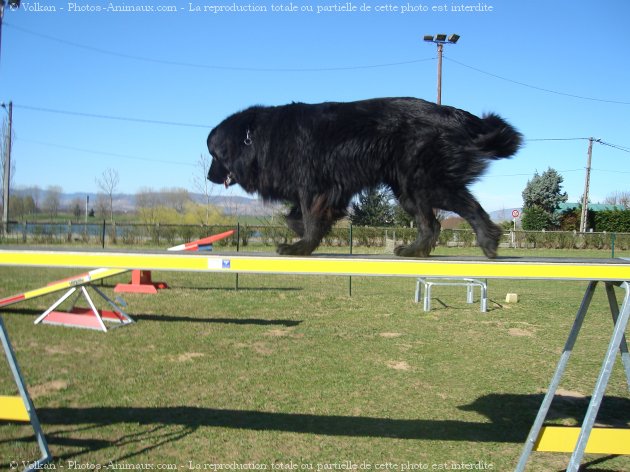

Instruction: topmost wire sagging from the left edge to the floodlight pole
[4,22,435,72]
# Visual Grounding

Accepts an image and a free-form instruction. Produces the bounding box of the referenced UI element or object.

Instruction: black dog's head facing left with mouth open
[207,110,258,193]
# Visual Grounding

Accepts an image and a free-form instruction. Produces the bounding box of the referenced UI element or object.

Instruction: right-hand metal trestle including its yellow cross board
[516,281,630,472]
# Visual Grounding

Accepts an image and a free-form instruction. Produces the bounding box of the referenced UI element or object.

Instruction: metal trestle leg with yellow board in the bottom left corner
[0,317,52,472]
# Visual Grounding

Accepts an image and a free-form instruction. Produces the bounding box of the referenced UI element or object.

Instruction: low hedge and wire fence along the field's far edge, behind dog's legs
[0,222,630,254]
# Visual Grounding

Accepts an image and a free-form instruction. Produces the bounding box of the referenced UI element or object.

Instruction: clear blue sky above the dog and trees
[0,0,630,211]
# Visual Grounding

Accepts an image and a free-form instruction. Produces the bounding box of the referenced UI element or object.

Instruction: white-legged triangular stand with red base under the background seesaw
[35,285,134,331]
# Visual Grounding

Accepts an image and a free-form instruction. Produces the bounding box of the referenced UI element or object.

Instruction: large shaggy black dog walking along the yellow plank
[208,98,522,257]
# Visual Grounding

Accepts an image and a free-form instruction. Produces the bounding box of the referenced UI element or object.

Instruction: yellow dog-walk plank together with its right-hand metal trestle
[0,250,630,472]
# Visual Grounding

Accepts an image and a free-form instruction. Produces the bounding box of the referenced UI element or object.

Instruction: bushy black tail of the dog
[473,113,523,159]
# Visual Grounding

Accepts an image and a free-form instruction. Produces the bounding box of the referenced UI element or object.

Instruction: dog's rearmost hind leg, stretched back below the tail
[444,189,503,259]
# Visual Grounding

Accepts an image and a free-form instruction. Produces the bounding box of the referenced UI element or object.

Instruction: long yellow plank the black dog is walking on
[0,250,630,281]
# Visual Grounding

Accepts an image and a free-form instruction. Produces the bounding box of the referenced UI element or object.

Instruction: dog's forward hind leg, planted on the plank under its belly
[394,196,440,257]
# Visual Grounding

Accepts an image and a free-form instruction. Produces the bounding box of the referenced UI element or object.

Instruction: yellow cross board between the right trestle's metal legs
[534,426,630,455]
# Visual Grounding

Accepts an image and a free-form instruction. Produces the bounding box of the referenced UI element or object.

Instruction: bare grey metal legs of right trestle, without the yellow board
[515,281,630,472]
